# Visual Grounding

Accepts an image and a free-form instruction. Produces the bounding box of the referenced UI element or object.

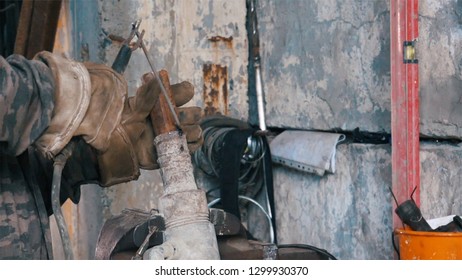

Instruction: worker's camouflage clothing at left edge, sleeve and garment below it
[0,55,54,259]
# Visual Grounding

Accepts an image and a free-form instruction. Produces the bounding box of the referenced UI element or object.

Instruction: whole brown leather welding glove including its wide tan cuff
[34,52,203,186]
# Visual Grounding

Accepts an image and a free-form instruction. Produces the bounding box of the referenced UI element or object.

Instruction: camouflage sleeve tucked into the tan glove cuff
[0,55,54,155]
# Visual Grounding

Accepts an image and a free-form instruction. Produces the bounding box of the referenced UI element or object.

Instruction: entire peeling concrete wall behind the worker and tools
[62,0,462,259]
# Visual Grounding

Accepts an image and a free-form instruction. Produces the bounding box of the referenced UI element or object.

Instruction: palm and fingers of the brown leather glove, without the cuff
[96,68,203,186]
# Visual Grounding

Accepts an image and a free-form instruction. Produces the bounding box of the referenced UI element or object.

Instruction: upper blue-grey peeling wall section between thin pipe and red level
[258,0,390,132]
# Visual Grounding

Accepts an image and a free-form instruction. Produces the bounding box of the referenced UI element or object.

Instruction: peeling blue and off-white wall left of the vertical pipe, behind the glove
[65,0,247,259]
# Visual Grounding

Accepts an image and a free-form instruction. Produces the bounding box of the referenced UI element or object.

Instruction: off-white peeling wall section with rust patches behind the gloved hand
[94,0,247,216]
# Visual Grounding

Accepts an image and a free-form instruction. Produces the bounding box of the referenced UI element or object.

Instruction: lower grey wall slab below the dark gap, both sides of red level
[274,143,462,259]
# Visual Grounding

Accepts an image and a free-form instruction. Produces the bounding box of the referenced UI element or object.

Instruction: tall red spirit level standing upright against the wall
[390,0,420,228]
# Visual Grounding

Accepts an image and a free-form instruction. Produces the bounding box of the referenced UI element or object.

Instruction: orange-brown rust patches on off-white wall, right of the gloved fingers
[202,63,228,116]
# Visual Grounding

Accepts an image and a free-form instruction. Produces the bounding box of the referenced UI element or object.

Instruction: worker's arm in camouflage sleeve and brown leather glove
[0,52,202,211]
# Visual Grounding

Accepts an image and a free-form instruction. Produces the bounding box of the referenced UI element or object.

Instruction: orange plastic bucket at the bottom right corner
[394,229,462,260]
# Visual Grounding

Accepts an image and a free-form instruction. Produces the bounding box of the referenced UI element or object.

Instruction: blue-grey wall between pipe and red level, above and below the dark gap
[259,0,394,259]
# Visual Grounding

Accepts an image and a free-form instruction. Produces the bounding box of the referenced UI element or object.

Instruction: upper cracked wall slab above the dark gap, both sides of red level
[259,0,462,139]
